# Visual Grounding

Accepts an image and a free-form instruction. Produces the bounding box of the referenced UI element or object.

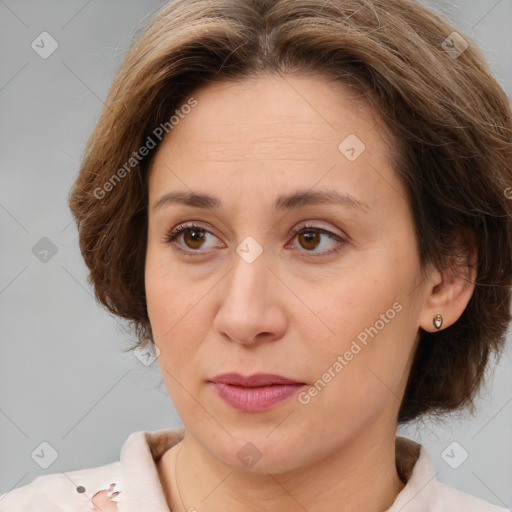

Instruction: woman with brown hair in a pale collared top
[0,0,512,512]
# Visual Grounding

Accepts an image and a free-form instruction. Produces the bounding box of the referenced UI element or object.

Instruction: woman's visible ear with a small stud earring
[419,233,478,332]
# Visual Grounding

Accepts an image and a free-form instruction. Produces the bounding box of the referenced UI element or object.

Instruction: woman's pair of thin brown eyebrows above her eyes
[153,190,370,211]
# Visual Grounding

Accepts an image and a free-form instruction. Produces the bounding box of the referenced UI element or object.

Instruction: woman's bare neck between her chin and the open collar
[158,420,405,512]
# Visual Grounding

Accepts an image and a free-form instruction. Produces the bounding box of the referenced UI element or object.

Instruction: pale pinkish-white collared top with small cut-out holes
[0,427,509,512]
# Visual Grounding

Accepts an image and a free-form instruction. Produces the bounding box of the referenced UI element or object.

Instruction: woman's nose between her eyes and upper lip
[213,246,287,345]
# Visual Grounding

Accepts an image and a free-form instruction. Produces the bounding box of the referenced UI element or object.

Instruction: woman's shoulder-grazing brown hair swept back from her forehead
[70,0,512,423]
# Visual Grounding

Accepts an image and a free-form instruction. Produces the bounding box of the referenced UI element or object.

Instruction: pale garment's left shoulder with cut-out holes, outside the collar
[0,462,121,512]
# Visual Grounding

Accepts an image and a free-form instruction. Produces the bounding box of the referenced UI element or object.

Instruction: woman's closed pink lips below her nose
[210,373,305,412]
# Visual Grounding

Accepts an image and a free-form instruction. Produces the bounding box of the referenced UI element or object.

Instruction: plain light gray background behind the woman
[0,0,512,508]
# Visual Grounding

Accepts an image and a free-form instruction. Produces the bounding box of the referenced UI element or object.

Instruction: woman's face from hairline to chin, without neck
[145,75,433,472]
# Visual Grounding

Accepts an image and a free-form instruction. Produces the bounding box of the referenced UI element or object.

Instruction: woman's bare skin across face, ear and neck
[145,74,474,512]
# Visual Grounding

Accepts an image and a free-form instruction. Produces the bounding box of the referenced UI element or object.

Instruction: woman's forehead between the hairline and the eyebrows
[150,74,398,210]
